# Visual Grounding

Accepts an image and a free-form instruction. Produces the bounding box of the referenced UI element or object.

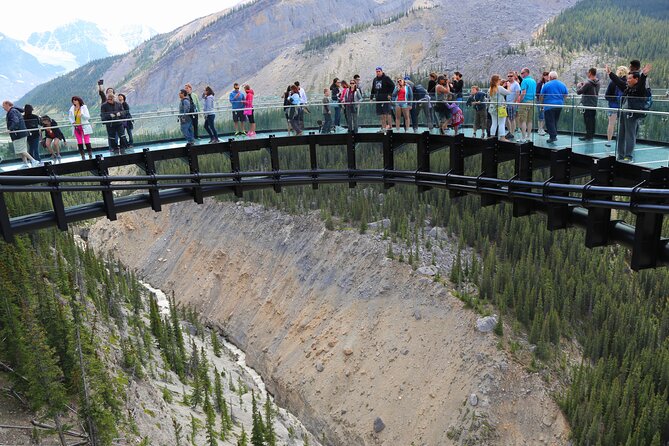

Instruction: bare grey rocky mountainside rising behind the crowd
[18,0,577,106]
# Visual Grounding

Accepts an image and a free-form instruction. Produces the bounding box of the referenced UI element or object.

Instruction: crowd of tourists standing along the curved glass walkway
[2,60,652,167]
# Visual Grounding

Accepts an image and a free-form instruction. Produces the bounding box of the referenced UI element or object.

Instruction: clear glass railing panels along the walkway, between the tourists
[0,94,669,168]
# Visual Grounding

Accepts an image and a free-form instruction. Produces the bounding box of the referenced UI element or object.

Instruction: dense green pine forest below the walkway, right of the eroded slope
[163,140,669,445]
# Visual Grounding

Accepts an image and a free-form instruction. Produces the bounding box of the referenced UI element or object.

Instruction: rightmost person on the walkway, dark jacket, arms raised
[606,64,652,162]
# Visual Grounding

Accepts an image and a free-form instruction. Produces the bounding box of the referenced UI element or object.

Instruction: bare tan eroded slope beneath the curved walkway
[89,201,568,445]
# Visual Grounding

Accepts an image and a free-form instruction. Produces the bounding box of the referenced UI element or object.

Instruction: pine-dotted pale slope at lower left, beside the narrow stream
[0,191,304,446]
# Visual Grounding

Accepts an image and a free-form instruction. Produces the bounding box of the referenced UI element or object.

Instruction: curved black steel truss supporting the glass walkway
[0,132,669,270]
